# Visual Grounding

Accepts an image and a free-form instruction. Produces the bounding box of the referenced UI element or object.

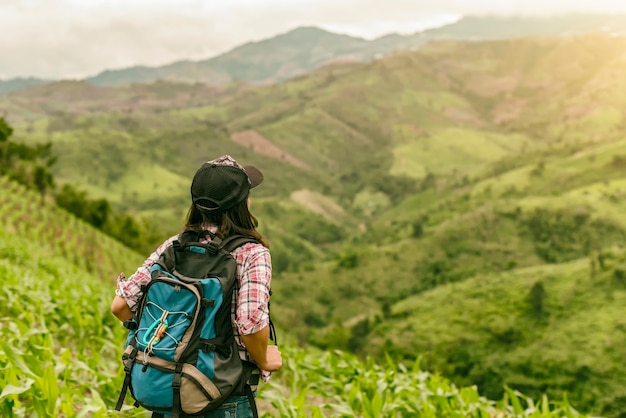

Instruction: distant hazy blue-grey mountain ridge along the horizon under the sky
[0,15,626,93]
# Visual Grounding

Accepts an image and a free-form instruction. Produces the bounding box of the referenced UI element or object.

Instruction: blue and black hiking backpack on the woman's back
[116,231,264,417]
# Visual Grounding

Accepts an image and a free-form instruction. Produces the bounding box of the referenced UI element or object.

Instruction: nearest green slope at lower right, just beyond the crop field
[367,256,626,416]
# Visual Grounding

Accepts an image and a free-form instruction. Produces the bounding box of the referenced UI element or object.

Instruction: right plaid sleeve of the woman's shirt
[236,244,272,335]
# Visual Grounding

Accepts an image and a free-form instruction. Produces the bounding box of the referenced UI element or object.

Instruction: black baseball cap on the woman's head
[191,155,263,211]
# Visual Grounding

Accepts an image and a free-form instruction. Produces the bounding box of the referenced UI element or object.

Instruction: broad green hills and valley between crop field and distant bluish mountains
[0,35,626,417]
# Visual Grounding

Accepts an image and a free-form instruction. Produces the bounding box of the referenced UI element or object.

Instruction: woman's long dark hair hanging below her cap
[185,198,270,248]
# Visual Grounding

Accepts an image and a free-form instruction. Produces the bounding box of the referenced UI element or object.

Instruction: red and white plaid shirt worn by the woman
[115,226,272,381]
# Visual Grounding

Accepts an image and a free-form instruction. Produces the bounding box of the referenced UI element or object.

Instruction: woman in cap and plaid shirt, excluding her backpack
[111,155,282,418]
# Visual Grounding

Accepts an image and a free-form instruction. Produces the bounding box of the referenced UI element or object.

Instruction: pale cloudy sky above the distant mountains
[0,0,626,79]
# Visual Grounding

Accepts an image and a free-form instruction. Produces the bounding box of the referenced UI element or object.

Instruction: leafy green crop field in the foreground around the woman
[0,177,574,417]
